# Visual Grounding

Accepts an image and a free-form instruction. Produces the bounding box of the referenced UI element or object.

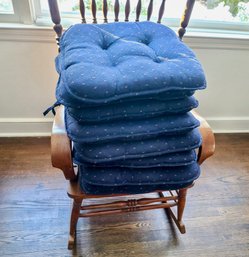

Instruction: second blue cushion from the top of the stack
[67,96,198,122]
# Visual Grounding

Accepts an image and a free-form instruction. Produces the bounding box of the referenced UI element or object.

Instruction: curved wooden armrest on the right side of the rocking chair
[192,111,215,164]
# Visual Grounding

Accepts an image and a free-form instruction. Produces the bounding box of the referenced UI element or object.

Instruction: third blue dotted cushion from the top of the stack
[65,109,200,143]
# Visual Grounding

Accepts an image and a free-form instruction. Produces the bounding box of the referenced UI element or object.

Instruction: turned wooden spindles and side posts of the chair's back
[48,0,195,45]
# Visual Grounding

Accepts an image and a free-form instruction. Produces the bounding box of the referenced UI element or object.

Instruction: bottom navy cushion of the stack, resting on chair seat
[79,163,200,194]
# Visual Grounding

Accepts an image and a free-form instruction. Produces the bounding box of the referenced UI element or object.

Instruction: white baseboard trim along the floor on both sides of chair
[0,117,249,137]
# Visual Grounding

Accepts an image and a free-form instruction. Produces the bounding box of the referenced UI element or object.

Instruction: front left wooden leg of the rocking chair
[68,198,83,249]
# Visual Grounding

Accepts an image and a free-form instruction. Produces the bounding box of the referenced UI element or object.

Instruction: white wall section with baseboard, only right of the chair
[187,38,249,132]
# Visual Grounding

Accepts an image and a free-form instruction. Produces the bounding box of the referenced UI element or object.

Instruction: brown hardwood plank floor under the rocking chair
[0,134,249,257]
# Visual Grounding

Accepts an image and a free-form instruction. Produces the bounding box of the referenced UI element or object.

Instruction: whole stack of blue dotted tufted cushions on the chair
[56,22,206,194]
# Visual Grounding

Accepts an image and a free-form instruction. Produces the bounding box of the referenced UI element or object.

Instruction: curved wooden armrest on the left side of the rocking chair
[51,105,77,180]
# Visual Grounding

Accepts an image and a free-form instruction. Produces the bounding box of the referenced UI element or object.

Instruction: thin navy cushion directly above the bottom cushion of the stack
[73,150,197,168]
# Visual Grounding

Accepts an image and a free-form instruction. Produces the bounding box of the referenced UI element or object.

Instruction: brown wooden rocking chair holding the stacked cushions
[48,0,215,249]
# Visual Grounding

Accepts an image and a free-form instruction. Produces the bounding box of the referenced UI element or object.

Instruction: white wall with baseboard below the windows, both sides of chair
[0,28,249,136]
